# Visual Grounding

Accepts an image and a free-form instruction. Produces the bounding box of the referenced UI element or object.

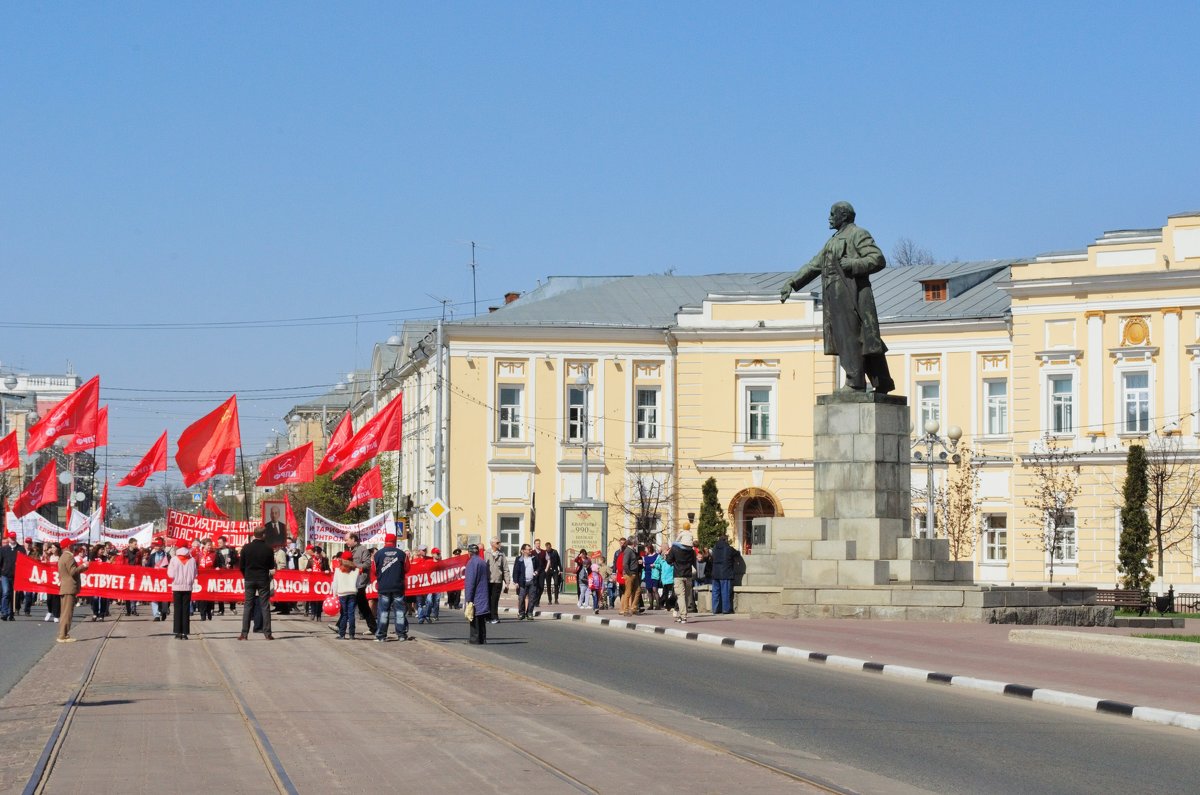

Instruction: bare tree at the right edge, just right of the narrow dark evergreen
[1146,436,1200,582]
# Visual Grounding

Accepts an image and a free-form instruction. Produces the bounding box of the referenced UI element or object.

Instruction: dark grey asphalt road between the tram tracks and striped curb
[412,612,1200,794]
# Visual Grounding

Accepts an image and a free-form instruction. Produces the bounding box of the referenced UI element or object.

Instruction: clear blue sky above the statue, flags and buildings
[0,1,1200,483]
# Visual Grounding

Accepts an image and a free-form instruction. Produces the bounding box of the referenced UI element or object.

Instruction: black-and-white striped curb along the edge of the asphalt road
[500,608,1200,731]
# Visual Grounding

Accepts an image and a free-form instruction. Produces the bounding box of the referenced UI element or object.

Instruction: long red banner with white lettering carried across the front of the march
[13,555,467,602]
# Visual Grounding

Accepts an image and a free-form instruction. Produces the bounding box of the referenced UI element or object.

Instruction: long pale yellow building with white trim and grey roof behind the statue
[392,214,1200,587]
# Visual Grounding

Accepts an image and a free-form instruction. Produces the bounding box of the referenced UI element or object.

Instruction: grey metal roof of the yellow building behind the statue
[455,259,1013,329]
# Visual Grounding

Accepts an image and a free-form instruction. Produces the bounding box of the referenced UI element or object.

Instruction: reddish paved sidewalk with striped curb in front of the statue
[502,594,1200,729]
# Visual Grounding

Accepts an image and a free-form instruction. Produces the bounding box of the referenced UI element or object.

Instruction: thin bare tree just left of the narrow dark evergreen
[1022,437,1080,580]
